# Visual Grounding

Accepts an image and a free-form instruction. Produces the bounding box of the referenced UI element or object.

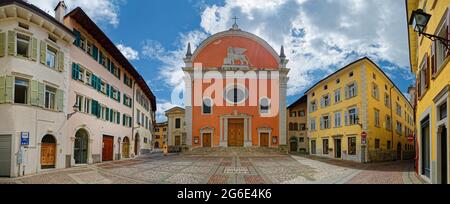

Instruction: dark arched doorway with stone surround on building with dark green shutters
[73,129,89,164]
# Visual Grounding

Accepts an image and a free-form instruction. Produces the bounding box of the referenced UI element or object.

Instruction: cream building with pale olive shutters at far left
[0,0,74,177]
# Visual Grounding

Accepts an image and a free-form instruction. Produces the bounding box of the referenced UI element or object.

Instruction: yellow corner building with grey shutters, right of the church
[306,58,414,162]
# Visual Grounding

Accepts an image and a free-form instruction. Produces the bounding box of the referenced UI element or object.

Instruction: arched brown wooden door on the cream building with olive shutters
[41,135,56,169]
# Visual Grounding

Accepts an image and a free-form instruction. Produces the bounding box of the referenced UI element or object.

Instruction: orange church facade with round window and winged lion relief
[183,24,289,148]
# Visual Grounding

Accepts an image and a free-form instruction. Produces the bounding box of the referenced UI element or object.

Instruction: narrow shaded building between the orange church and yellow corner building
[287,95,309,153]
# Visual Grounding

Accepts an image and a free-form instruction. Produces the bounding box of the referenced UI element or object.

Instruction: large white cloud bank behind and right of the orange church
[147,0,411,98]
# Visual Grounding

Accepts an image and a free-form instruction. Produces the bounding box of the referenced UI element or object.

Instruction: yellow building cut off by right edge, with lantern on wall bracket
[406,0,450,184]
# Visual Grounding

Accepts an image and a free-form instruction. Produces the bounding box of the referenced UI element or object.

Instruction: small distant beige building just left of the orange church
[166,107,187,147]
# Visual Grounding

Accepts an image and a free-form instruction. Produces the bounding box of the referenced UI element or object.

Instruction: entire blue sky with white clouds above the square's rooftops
[28,0,414,122]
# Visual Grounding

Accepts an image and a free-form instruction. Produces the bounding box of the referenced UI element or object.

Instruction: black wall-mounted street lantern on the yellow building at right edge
[409,9,450,49]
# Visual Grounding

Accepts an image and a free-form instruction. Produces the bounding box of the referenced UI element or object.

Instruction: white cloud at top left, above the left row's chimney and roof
[28,0,126,27]
